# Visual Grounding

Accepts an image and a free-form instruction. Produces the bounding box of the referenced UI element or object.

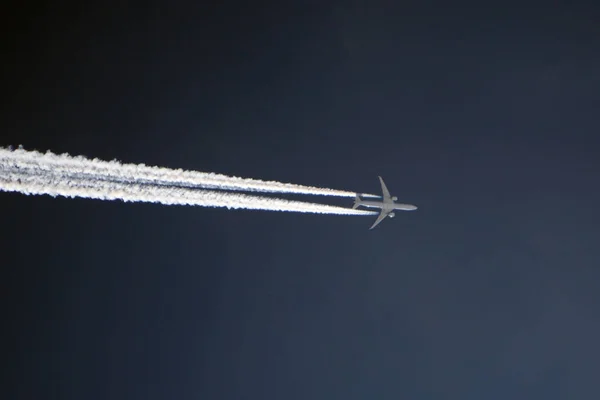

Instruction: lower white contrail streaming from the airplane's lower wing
[0,151,376,215]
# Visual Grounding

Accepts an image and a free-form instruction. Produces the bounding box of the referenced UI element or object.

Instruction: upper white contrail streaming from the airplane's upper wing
[0,148,379,197]
